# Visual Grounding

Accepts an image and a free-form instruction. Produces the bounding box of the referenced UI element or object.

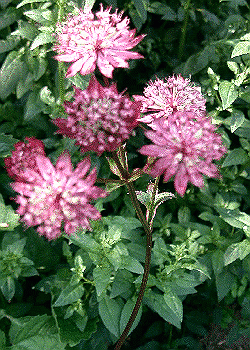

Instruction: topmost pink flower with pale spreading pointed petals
[54,5,145,78]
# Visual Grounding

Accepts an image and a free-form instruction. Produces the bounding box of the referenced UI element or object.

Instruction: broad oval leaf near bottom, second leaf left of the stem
[99,295,124,338]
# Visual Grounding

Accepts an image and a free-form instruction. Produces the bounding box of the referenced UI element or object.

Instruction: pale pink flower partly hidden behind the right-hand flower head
[133,75,206,124]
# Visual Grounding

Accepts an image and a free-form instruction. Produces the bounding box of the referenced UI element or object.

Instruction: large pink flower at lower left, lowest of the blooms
[11,152,107,240]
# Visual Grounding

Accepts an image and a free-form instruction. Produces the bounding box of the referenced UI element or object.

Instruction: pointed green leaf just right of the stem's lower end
[144,290,181,329]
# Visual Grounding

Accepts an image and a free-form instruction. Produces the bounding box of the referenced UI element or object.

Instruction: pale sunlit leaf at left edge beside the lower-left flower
[0,193,20,231]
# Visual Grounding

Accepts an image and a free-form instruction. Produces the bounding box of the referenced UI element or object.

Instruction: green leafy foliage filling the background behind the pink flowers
[0,0,250,350]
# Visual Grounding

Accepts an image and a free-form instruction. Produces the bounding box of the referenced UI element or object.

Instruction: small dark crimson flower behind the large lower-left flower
[4,137,45,180]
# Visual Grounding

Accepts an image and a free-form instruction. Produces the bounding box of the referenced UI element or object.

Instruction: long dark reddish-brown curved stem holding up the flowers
[113,149,152,350]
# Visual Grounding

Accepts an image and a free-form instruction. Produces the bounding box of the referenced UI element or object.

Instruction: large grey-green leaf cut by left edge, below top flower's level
[0,51,28,100]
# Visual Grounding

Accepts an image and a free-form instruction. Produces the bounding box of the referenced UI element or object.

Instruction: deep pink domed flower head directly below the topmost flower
[53,76,140,155]
